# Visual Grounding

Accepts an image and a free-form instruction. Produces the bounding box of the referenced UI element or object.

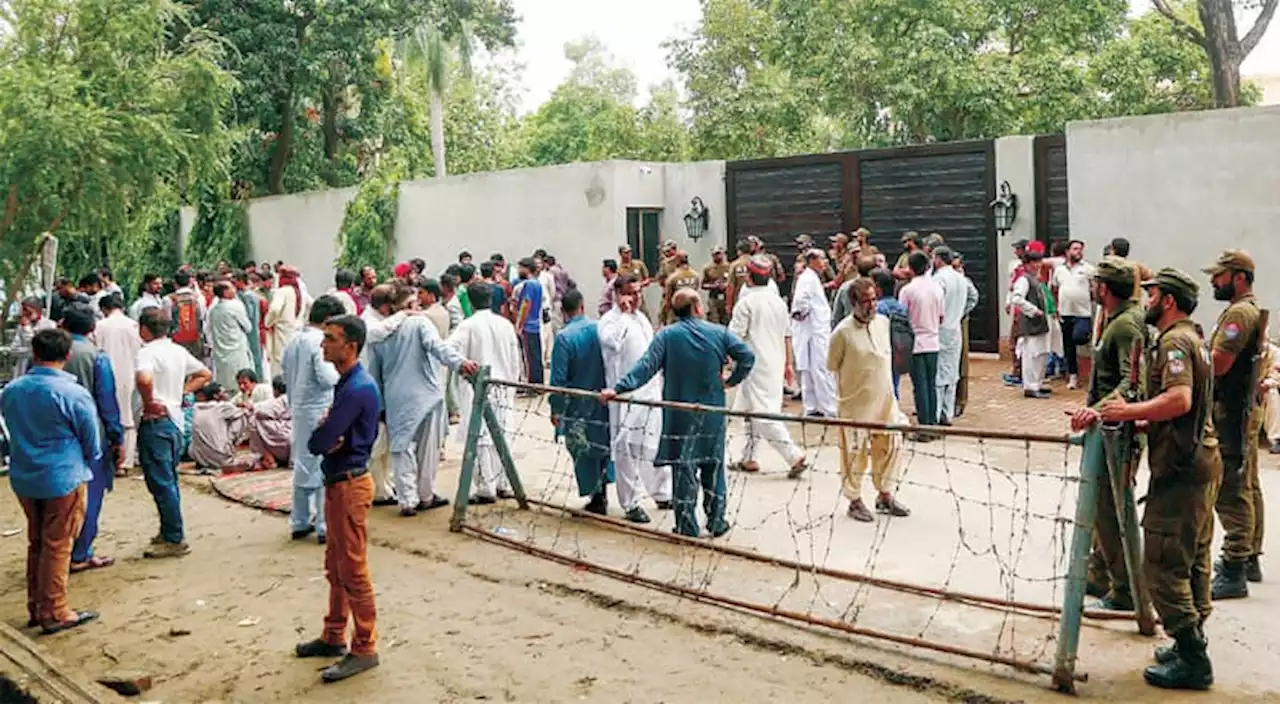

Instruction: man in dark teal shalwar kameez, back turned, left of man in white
[550,289,629,524]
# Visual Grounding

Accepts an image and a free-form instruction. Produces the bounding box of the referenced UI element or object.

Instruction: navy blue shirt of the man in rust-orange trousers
[307,362,381,476]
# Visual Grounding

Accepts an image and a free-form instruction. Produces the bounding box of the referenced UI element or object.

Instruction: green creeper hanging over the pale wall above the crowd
[334,156,404,276]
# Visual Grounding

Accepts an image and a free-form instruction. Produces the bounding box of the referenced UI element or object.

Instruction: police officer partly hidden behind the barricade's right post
[1071,257,1147,611]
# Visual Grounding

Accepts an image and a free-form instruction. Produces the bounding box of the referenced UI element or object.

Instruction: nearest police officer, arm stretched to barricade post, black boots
[1101,269,1222,690]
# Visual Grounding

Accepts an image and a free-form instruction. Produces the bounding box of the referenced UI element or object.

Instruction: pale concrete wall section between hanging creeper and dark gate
[396,161,724,316]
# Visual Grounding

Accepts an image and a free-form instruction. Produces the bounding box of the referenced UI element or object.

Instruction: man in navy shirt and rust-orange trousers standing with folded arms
[296,315,380,682]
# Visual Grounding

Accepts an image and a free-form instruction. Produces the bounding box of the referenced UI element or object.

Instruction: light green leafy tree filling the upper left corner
[0,0,234,301]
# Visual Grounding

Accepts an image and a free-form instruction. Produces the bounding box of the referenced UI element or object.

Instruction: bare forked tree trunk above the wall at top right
[1152,0,1277,108]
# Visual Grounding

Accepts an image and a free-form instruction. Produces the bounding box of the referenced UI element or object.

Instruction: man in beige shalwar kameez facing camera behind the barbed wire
[827,278,910,522]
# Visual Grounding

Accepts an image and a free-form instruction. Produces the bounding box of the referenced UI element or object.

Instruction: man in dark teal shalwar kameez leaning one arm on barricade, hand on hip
[600,289,755,538]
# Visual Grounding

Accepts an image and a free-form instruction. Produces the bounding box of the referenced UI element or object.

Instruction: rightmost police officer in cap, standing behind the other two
[1204,250,1270,599]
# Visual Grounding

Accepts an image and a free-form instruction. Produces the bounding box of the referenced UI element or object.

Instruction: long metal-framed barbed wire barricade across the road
[452,370,1134,690]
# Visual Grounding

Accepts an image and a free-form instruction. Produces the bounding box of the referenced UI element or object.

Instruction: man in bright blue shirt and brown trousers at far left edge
[0,330,102,634]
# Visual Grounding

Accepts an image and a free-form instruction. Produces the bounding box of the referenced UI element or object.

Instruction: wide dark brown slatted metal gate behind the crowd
[724,140,1001,352]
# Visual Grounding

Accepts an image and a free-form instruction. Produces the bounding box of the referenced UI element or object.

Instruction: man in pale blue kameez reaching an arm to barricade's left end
[369,288,477,517]
